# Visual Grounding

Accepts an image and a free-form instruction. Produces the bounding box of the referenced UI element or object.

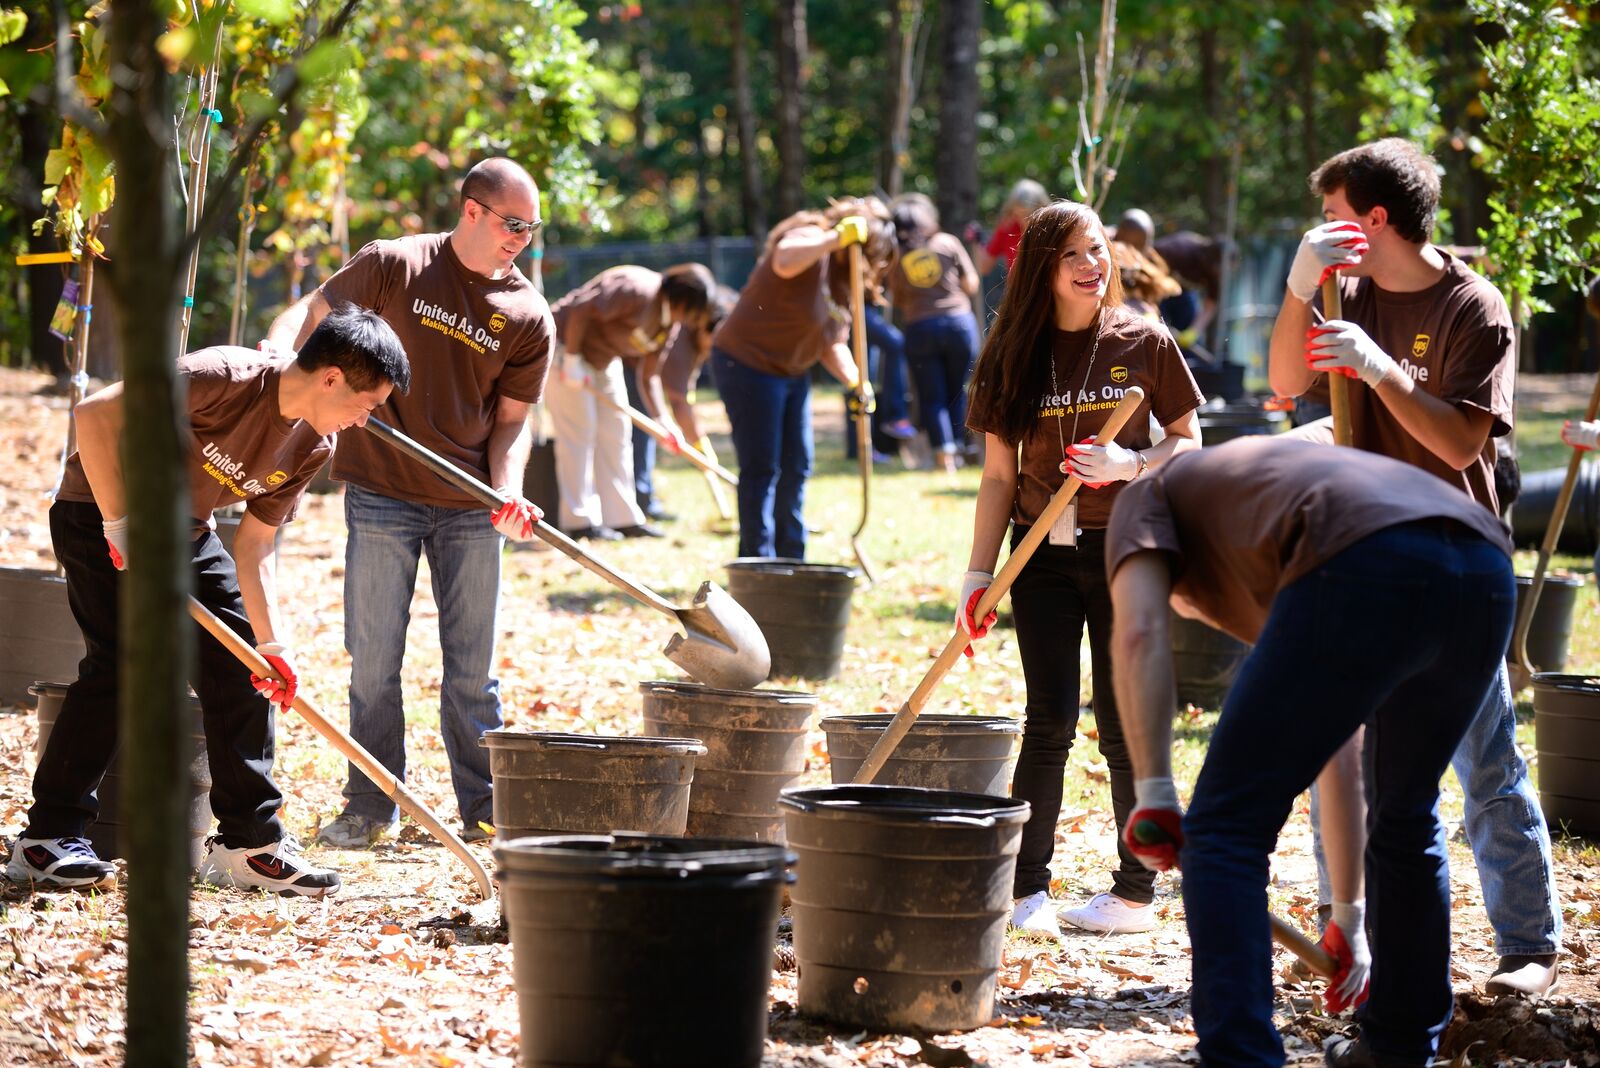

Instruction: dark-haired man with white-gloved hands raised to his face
[1269,137,1562,994]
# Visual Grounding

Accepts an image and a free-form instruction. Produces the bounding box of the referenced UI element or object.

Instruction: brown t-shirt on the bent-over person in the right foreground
[1106,435,1510,643]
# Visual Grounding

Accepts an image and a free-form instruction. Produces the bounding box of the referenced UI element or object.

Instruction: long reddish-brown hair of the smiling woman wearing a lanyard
[970,200,1122,446]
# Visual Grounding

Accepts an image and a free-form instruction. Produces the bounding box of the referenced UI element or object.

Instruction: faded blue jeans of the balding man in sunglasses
[344,484,502,827]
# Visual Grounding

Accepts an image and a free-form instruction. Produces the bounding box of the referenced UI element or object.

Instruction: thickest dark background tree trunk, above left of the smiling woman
[934,0,982,233]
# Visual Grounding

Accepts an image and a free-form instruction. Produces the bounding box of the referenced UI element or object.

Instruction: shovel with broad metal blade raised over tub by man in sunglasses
[365,419,773,689]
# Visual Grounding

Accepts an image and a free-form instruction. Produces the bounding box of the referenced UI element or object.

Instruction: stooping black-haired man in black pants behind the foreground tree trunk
[6,309,410,897]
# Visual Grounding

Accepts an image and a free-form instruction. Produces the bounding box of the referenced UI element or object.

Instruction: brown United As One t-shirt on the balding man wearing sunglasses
[322,233,555,508]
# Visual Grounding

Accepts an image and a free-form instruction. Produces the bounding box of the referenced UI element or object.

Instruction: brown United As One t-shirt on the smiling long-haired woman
[966,309,1205,529]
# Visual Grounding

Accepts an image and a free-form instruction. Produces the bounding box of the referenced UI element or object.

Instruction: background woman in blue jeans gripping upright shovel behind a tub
[710,197,894,560]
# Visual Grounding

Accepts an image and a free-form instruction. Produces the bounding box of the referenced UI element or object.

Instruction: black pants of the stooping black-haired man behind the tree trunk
[24,500,283,849]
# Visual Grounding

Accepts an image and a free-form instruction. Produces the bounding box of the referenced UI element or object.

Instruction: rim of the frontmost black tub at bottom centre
[493,833,795,881]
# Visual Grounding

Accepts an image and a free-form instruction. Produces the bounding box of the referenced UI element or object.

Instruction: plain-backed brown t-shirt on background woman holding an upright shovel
[710,238,845,377]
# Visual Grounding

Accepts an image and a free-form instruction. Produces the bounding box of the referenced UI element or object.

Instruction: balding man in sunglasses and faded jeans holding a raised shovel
[270,158,554,849]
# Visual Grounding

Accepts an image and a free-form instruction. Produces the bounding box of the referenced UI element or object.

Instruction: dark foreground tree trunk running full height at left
[109,0,194,1068]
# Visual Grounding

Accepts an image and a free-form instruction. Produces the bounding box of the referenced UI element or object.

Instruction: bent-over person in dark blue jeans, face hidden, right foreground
[1106,438,1515,1066]
